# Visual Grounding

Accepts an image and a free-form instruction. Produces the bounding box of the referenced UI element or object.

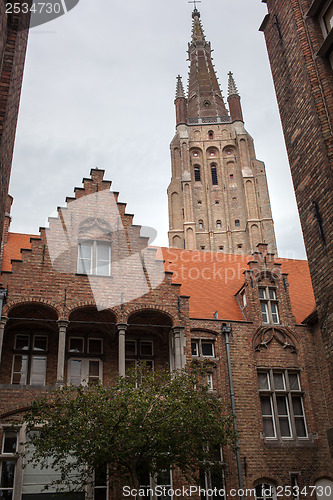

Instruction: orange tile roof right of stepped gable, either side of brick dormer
[162,248,315,323]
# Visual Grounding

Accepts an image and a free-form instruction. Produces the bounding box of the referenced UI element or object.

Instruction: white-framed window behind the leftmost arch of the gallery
[11,334,48,385]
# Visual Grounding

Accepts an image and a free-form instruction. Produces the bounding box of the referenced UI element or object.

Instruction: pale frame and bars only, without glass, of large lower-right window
[257,368,309,441]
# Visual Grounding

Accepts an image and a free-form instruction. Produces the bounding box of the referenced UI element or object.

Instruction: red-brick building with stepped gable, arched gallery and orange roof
[0,169,333,500]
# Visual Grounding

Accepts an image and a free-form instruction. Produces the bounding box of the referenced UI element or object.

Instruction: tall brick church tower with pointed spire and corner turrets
[168,9,276,253]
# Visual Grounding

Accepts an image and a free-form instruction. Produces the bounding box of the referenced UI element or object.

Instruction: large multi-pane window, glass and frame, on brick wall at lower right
[258,370,308,439]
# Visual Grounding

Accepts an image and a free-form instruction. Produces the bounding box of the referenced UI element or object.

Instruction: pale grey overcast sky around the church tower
[10,0,305,258]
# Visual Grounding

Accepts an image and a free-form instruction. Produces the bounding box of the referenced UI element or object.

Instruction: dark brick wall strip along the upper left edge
[0,0,31,250]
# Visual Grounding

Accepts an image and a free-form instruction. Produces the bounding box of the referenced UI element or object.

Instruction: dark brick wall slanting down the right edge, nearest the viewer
[260,0,333,394]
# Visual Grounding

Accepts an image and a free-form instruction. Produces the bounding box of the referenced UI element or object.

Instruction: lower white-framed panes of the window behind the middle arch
[67,358,103,386]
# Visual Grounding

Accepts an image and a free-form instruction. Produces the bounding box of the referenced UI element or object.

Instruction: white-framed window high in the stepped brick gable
[77,240,111,276]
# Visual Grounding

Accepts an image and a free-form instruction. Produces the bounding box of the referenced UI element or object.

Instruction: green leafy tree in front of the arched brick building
[26,367,234,498]
